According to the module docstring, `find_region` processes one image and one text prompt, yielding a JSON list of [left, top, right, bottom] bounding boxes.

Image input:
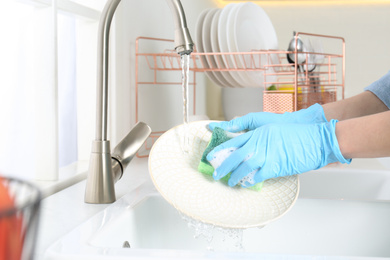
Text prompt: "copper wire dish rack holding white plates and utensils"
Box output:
[[135, 32, 345, 157]]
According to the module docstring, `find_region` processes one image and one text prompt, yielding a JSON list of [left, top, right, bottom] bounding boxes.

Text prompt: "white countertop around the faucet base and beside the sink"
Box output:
[[36, 155, 386, 260]]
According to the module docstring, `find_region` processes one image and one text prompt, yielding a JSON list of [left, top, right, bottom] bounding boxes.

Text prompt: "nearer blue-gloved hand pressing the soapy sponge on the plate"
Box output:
[[207, 119, 351, 187]]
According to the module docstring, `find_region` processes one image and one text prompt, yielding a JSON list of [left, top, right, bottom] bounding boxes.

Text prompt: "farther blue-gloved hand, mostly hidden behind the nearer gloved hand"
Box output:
[[209, 104, 327, 132]]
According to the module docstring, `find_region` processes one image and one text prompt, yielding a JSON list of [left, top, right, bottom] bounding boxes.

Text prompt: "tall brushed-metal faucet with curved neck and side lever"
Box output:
[[85, 0, 194, 204]]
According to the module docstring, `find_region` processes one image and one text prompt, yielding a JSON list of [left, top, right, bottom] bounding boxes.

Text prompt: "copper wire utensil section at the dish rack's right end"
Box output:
[[263, 32, 345, 113]]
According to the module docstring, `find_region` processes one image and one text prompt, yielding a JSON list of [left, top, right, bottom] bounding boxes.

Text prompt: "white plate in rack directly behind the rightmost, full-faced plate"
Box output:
[[218, 4, 245, 88]]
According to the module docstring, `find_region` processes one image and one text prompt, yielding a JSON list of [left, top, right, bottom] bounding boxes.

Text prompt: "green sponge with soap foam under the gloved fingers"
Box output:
[[198, 127, 263, 191]]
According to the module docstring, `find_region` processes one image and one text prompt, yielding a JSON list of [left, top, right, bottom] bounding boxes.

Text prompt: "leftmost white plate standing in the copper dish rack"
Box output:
[[195, 8, 224, 86]]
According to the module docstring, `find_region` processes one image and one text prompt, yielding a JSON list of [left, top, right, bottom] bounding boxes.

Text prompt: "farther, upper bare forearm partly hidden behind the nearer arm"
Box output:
[[322, 91, 388, 121]]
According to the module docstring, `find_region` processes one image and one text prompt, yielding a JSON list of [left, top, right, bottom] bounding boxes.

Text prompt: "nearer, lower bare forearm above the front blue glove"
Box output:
[[336, 111, 390, 159]]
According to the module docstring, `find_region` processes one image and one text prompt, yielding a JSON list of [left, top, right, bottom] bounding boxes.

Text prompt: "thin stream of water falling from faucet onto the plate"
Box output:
[[181, 54, 190, 153]]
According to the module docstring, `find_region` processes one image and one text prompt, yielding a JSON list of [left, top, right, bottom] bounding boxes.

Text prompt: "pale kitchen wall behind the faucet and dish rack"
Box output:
[[110, 0, 390, 148]]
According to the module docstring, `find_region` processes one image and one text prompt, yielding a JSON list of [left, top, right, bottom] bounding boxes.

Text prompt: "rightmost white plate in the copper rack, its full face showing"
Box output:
[[235, 2, 278, 87]]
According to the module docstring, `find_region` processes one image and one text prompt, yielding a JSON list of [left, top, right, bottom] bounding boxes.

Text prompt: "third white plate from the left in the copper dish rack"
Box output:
[[210, 9, 239, 88]]
